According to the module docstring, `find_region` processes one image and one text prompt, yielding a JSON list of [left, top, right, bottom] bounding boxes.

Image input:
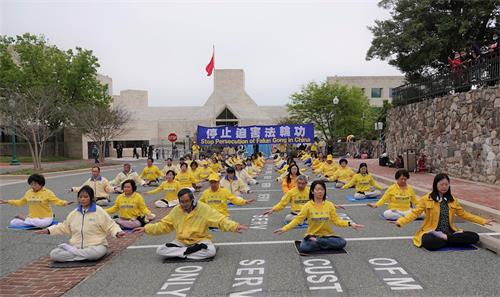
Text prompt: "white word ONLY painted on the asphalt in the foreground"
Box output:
[[156, 266, 203, 297]]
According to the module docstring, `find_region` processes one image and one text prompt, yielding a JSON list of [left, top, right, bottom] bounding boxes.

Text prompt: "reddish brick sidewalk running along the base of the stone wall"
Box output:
[[348, 159, 500, 210]]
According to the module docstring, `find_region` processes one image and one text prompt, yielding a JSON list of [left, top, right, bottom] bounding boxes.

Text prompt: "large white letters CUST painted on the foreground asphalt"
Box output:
[[302, 258, 345, 297]]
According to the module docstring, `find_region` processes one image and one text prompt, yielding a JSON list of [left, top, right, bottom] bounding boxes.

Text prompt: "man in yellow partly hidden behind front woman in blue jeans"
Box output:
[[264, 175, 310, 223]]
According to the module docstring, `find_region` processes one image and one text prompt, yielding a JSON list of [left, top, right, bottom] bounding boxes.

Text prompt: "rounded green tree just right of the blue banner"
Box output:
[[287, 82, 375, 142]]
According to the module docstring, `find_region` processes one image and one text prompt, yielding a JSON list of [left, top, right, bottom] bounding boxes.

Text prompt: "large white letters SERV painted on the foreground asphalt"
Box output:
[[229, 259, 266, 297]]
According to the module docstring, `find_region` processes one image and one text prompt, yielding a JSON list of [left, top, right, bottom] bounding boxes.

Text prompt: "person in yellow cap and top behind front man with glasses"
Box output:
[[198, 174, 255, 216]]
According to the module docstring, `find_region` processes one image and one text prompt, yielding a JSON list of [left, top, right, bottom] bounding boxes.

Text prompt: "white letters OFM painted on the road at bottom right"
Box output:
[[368, 258, 423, 291]]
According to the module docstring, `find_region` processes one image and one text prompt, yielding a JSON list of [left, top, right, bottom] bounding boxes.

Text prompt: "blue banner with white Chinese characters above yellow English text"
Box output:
[[197, 124, 314, 146]]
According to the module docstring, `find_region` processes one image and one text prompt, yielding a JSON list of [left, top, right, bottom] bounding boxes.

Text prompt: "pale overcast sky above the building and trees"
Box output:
[[0, 0, 401, 106]]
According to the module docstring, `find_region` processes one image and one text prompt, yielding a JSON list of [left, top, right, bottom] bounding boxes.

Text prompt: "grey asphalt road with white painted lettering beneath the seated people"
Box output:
[[0, 164, 500, 296]]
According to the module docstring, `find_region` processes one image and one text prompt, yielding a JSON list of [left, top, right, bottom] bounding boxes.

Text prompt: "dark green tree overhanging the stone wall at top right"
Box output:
[[366, 0, 500, 82]]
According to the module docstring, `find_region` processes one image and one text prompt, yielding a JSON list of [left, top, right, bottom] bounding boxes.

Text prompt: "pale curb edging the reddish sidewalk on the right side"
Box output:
[[372, 173, 500, 256]]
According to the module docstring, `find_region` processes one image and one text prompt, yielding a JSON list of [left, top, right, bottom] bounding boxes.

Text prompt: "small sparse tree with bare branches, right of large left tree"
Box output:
[[71, 104, 131, 162]]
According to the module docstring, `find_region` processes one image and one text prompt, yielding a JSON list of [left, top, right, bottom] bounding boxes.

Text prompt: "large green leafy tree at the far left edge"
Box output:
[[0, 33, 111, 170]]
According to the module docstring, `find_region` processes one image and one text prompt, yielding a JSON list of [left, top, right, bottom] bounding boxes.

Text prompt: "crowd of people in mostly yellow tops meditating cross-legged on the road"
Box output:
[[0, 153, 493, 262]]
